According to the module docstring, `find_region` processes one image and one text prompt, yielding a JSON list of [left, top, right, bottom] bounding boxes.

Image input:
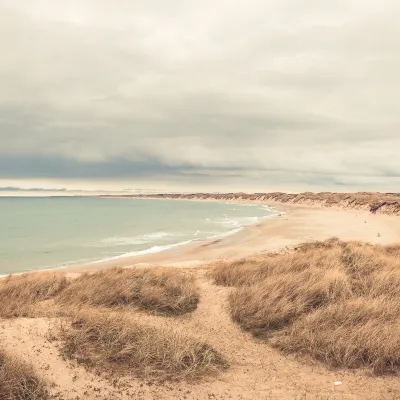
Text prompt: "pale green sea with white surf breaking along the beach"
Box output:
[[0, 197, 277, 275]]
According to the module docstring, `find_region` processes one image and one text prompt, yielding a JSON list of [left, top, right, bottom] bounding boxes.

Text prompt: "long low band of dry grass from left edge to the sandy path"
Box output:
[[0, 268, 199, 318]]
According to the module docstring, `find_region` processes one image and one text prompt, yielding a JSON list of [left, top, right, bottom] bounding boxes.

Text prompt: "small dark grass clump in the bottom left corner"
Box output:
[[0, 350, 48, 400]]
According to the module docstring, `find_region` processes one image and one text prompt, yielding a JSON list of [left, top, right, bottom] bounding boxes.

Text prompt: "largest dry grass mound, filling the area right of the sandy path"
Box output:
[[212, 239, 400, 373]]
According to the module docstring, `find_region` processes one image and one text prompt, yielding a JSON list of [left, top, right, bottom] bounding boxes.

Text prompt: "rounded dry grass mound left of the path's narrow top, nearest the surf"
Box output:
[[57, 268, 199, 315]]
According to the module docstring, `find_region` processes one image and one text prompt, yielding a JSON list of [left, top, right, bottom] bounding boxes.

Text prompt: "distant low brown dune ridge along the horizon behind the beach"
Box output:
[[105, 192, 400, 215]]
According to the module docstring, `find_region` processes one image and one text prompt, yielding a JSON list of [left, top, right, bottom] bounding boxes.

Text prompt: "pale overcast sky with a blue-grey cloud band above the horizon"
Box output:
[[0, 0, 400, 193]]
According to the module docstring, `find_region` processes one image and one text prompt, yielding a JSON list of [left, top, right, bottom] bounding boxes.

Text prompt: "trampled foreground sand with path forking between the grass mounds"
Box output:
[[0, 268, 400, 399]]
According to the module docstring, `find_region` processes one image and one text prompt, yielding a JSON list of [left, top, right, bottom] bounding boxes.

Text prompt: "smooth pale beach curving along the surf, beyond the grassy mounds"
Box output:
[[65, 200, 400, 273]]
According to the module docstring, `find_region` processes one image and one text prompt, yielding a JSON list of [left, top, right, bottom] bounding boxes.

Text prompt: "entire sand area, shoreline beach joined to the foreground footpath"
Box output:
[[0, 203, 400, 400]]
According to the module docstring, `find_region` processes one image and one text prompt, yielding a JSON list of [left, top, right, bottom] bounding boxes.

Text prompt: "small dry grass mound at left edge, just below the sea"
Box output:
[[0, 272, 68, 318]]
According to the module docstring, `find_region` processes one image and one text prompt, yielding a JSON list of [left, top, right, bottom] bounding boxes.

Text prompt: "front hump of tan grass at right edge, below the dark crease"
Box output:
[[272, 297, 400, 374]]
